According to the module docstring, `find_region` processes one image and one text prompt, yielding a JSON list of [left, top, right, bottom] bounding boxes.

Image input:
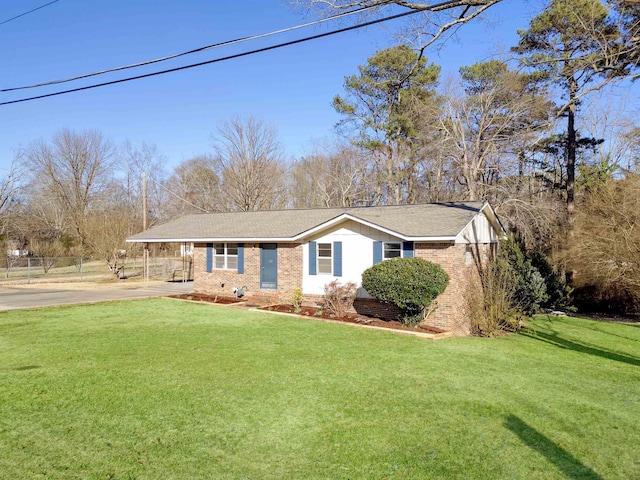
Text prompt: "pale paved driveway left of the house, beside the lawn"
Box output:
[[0, 282, 193, 311]]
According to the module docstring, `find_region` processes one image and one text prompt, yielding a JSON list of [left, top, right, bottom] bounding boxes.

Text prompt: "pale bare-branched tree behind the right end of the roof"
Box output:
[[439, 60, 550, 201]]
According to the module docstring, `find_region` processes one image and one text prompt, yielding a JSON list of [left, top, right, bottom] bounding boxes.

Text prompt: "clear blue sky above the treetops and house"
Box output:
[[0, 0, 568, 175]]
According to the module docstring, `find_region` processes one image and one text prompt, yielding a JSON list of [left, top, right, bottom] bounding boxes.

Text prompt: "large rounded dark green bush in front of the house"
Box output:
[[362, 258, 449, 325]]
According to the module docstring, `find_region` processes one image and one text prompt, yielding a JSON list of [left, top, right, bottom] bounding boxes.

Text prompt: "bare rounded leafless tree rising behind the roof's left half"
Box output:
[[213, 118, 286, 211]]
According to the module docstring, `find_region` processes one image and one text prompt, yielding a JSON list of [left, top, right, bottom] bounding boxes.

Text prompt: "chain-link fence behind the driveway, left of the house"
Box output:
[[0, 255, 193, 284]]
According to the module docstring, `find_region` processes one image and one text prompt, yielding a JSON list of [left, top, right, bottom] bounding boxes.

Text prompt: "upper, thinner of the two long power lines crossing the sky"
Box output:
[[0, 0, 389, 93]]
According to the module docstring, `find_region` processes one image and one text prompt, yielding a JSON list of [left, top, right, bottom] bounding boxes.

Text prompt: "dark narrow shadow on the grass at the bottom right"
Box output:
[[505, 415, 602, 480]]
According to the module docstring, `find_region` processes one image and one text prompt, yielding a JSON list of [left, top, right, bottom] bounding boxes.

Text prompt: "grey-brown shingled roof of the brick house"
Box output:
[[127, 202, 495, 242]]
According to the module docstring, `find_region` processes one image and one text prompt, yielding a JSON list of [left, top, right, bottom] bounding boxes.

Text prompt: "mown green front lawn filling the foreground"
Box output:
[[0, 299, 640, 479]]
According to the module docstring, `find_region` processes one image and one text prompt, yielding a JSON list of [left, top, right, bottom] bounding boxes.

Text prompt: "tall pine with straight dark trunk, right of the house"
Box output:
[[513, 0, 620, 212]]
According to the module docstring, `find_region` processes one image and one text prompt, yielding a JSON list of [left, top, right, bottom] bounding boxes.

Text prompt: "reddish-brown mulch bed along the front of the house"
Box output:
[[169, 293, 444, 333]]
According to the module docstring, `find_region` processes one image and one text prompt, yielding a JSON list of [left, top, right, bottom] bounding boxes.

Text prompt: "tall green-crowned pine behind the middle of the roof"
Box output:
[[333, 45, 440, 204]]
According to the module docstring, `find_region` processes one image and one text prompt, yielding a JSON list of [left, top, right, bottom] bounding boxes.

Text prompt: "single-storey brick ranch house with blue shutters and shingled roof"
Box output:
[[127, 202, 504, 331]]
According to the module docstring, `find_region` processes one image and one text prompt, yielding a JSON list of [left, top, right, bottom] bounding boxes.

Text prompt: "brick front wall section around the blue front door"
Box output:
[[193, 243, 302, 303]]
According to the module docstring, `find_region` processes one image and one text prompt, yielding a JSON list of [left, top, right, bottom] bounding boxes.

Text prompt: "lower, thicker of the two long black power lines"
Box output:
[[0, 6, 420, 106]]
